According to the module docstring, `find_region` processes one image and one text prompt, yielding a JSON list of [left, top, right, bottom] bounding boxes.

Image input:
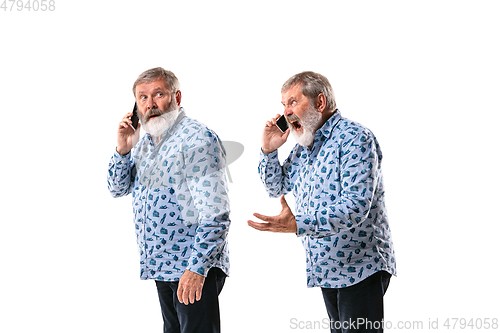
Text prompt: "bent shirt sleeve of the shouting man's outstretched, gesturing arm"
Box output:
[[295, 132, 382, 238]]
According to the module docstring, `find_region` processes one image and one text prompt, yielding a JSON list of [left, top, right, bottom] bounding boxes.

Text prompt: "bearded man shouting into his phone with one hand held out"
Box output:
[[248, 72, 396, 332]]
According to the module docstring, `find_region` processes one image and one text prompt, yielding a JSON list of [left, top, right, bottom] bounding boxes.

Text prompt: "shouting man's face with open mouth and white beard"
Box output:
[[281, 84, 321, 146]]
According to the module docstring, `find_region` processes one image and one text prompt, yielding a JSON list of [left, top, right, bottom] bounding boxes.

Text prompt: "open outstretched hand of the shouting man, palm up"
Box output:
[[248, 194, 297, 233]]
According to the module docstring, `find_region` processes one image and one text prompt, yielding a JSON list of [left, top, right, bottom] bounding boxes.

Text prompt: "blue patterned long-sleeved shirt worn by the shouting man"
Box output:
[[259, 110, 396, 288]]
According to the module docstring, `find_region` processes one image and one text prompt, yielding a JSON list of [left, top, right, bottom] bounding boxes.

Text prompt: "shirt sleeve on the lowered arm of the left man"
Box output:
[[184, 130, 230, 276]]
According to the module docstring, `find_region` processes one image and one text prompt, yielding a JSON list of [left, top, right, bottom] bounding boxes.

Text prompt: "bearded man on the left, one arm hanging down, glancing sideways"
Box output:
[[108, 68, 230, 333]]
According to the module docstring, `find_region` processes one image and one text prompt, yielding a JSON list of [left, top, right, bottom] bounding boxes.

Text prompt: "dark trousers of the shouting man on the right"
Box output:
[[321, 271, 391, 333]]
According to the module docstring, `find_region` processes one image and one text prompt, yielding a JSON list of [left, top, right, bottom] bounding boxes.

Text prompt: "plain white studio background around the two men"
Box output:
[[0, 0, 500, 333]]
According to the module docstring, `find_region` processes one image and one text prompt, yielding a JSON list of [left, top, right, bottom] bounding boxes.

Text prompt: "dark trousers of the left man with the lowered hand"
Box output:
[[155, 268, 226, 333]]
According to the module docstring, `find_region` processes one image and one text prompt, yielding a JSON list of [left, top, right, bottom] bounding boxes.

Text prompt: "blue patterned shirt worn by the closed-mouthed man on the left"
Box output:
[[108, 109, 230, 281]]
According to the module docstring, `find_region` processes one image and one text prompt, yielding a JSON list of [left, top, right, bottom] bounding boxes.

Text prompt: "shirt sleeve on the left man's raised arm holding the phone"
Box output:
[[108, 151, 135, 198]]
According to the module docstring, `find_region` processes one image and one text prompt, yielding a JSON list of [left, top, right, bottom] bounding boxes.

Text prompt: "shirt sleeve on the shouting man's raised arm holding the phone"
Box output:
[[258, 149, 293, 198]]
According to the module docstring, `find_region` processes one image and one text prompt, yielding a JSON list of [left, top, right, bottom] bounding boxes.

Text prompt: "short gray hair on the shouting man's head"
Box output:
[[281, 71, 337, 111]]
